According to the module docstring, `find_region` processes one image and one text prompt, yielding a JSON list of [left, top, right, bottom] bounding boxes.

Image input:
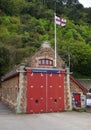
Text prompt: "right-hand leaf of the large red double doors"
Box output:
[[47, 74, 64, 112]]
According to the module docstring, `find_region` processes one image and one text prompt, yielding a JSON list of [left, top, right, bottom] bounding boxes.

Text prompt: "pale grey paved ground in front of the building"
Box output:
[[0, 102, 91, 130]]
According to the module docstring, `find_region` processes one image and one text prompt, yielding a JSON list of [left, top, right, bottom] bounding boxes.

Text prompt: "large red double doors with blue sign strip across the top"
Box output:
[[27, 69, 64, 113]]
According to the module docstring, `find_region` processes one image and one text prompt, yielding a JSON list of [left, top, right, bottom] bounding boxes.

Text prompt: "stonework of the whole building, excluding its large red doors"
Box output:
[[2, 42, 87, 113]]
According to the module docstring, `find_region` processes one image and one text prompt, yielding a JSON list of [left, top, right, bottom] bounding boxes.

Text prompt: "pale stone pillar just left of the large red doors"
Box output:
[[16, 66, 26, 113]]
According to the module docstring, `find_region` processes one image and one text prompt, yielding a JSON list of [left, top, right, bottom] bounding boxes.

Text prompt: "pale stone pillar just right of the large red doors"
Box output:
[[66, 68, 72, 110]]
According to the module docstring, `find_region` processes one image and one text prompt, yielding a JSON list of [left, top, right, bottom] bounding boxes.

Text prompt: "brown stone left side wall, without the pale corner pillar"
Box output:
[[2, 76, 19, 110]]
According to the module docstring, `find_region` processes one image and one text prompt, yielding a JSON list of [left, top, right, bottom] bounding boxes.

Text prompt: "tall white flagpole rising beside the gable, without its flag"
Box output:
[[54, 13, 57, 67]]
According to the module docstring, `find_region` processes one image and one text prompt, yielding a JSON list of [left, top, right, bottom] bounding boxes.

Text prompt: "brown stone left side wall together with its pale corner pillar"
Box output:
[[1, 70, 27, 113]]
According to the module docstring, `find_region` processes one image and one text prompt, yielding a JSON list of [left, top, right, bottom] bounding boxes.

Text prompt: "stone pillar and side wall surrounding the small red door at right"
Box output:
[[64, 72, 86, 110]]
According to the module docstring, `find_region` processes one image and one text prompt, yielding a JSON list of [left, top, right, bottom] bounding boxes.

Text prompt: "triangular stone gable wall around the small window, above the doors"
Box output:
[[26, 43, 65, 68]]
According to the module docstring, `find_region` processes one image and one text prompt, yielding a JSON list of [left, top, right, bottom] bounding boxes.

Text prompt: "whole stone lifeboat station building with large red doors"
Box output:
[[1, 42, 87, 114]]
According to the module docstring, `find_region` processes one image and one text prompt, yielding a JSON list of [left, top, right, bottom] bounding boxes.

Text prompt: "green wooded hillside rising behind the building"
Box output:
[[0, 0, 91, 78]]
